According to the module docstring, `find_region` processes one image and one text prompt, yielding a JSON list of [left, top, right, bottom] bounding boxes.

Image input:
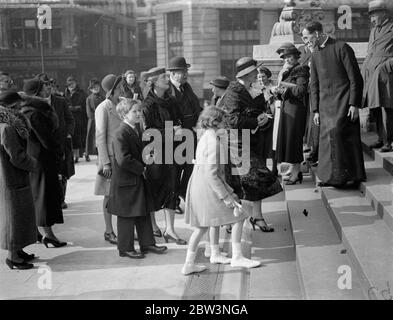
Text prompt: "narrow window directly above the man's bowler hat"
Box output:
[[167, 11, 183, 59]]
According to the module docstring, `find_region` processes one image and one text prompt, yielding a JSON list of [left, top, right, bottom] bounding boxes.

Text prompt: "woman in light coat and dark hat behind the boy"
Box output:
[[94, 74, 122, 244]]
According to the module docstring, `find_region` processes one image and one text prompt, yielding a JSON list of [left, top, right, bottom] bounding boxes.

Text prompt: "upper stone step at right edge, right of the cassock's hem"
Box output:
[[360, 157, 393, 232]]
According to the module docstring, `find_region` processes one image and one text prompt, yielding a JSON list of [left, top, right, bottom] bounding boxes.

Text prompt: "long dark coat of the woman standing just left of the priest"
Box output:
[[277, 65, 310, 163]]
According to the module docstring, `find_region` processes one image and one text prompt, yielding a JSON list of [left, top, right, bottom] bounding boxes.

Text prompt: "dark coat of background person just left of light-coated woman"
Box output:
[[86, 93, 105, 154]]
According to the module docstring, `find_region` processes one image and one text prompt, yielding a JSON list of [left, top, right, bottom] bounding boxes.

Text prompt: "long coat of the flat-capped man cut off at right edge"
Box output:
[[362, 20, 393, 108]]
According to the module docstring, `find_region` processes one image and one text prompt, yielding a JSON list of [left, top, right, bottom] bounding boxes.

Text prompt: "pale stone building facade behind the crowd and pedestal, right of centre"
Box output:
[[153, 0, 376, 99]]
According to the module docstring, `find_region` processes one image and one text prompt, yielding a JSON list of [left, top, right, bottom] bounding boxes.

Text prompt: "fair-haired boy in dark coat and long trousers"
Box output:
[[108, 99, 167, 259]]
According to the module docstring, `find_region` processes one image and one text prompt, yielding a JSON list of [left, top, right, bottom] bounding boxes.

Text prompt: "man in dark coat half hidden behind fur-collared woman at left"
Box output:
[[35, 73, 75, 209]]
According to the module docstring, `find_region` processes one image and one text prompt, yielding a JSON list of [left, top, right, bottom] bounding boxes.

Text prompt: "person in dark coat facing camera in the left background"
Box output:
[[64, 76, 87, 163]]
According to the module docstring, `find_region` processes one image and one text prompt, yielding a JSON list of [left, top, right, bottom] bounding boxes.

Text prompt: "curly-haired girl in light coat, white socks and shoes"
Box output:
[[182, 107, 260, 275]]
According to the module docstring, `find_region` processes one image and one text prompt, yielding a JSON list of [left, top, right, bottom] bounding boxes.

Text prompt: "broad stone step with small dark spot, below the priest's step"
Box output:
[[285, 176, 367, 300]]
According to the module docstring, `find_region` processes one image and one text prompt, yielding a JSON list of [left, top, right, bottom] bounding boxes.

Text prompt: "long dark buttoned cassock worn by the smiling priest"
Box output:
[[310, 38, 366, 185]]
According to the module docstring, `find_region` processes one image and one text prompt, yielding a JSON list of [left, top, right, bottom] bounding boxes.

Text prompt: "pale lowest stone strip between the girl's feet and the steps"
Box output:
[[249, 192, 303, 300]]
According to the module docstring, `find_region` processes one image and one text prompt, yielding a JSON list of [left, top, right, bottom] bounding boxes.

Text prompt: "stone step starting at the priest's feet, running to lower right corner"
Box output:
[[320, 187, 393, 300]]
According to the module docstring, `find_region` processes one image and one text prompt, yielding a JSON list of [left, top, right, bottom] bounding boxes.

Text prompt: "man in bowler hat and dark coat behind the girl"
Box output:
[[167, 57, 202, 213]]
